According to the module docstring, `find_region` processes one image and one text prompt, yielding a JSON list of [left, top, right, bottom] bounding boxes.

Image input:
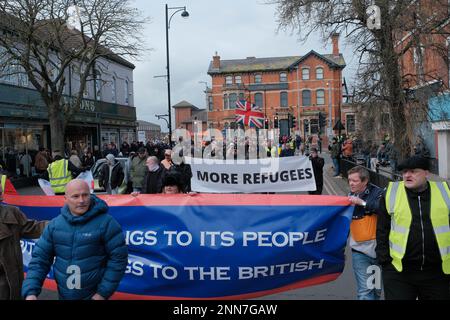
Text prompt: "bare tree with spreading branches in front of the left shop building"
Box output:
[[0, 0, 148, 151]]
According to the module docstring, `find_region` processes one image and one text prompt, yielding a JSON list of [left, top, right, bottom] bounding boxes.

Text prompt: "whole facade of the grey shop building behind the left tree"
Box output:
[[0, 54, 136, 161]]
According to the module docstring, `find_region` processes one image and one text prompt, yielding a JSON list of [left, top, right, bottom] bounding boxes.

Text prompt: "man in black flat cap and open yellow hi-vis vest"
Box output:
[[376, 156, 450, 300]]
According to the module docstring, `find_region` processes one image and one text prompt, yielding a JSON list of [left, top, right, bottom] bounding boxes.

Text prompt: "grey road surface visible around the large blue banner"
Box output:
[[14, 152, 356, 300]]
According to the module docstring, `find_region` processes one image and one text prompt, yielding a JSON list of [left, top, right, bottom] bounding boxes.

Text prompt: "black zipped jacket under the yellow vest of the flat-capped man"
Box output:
[[376, 183, 442, 271]]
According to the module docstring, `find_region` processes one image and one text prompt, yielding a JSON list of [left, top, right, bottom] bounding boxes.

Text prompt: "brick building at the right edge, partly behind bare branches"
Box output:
[[395, 1, 450, 179]]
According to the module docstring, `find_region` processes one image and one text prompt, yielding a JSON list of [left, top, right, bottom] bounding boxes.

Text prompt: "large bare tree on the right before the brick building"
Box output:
[[268, 0, 449, 156]]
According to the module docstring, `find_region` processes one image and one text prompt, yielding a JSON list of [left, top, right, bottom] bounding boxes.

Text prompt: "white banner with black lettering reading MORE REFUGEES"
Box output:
[[185, 157, 316, 193]]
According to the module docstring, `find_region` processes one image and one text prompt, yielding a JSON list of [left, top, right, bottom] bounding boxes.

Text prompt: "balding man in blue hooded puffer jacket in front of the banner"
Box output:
[[22, 180, 128, 300]]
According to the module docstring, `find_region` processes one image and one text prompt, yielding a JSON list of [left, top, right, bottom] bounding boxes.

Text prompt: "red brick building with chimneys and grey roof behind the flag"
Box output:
[[207, 34, 345, 141]]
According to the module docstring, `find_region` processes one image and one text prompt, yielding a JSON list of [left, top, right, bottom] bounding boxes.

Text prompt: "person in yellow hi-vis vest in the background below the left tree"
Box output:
[[47, 151, 82, 195]]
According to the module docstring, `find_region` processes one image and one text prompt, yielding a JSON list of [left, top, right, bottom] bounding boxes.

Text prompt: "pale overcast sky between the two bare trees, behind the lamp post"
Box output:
[[133, 0, 356, 131]]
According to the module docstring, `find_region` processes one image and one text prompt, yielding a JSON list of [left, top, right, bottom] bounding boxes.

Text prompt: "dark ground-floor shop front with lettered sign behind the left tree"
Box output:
[[0, 83, 136, 174]]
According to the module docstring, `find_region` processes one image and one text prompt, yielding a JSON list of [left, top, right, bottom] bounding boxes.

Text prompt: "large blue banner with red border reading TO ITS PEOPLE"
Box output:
[[5, 194, 353, 299]]
